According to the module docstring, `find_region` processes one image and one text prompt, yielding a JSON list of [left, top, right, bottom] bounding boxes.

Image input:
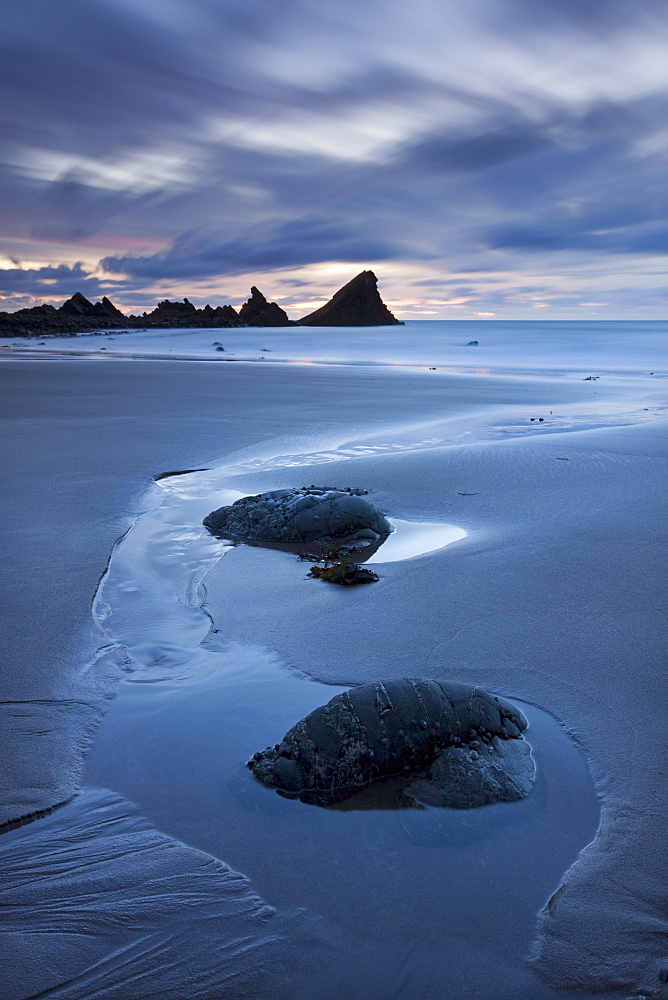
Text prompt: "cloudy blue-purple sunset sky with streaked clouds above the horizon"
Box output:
[[0, 0, 668, 319]]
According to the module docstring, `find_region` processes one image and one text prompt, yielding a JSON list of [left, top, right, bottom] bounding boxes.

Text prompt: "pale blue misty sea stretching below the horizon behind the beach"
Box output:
[[6, 320, 668, 378]]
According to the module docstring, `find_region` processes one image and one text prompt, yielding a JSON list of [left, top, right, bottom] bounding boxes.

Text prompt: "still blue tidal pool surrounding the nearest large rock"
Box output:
[[85, 644, 599, 962]]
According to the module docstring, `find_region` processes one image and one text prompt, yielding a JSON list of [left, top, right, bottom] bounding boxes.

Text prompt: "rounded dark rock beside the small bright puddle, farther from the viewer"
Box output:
[[204, 486, 392, 554]]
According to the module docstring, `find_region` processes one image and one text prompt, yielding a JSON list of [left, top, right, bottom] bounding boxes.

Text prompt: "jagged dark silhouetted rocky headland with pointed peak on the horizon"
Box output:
[[0, 271, 401, 337]]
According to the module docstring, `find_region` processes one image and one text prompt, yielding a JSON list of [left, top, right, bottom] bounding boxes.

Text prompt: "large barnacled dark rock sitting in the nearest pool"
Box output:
[[248, 677, 535, 809]]
